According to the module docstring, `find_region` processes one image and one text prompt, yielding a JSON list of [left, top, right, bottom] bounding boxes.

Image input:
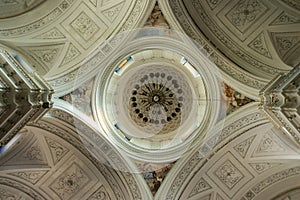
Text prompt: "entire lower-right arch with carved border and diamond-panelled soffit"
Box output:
[[155, 103, 300, 199]]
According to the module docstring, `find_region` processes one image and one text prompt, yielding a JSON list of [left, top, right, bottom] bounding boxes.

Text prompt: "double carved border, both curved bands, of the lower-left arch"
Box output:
[[30, 103, 151, 199]]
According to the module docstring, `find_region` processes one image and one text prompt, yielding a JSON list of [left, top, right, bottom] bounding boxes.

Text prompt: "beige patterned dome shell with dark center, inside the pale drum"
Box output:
[[116, 64, 193, 136]]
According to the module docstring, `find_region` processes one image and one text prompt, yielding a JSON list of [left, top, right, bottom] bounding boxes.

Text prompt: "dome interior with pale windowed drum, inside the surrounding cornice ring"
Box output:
[[103, 49, 205, 149]]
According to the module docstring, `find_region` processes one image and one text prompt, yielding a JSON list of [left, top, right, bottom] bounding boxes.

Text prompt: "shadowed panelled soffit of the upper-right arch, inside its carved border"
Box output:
[[177, 0, 299, 74]]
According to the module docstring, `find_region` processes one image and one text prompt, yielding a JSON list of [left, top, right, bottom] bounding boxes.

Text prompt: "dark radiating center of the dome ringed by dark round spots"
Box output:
[[129, 72, 184, 125]]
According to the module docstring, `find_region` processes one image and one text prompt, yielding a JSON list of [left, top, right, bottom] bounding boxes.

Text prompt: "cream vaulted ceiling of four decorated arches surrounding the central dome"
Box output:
[[0, 0, 300, 200]]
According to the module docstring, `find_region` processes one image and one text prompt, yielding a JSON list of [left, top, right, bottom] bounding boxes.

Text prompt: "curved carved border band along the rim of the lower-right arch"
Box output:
[[155, 103, 267, 200]]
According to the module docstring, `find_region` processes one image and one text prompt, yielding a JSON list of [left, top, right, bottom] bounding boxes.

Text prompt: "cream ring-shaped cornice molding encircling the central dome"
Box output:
[[92, 28, 223, 162]]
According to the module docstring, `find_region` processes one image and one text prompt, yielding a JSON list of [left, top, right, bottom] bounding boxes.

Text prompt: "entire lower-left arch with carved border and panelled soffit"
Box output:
[[0, 101, 152, 199]]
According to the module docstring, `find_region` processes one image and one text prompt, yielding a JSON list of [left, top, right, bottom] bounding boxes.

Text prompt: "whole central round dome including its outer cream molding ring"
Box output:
[[92, 29, 225, 162]]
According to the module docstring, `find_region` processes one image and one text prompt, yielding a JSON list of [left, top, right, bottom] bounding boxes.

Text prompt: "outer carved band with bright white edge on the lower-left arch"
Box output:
[[36, 103, 151, 199]]
